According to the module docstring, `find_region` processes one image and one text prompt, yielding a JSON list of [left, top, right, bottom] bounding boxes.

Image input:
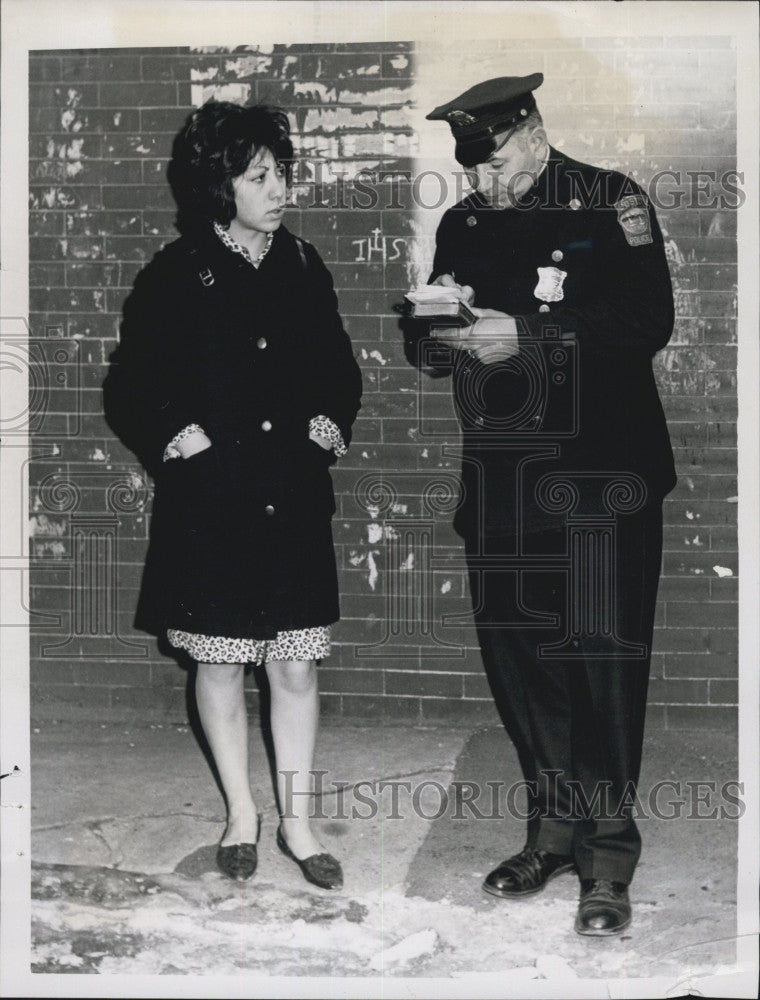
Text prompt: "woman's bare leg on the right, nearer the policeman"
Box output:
[[266, 660, 324, 858]]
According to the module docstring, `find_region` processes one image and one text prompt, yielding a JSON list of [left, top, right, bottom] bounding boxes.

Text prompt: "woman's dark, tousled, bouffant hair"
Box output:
[[168, 101, 293, 232]]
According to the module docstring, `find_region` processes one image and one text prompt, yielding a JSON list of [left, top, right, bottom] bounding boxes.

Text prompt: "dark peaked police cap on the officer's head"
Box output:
[[425, 73, 544, 167]]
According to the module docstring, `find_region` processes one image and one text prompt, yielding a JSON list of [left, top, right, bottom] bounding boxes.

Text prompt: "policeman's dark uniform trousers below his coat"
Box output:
[[467, 506, 662, 884]]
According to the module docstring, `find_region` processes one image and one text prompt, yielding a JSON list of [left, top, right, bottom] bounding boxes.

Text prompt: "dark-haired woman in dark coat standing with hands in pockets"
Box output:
[[104, 101, 361, 889]]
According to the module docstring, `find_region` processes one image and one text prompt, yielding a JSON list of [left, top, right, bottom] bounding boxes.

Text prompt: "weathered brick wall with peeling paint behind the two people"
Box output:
[[30, 38, 738, 727]]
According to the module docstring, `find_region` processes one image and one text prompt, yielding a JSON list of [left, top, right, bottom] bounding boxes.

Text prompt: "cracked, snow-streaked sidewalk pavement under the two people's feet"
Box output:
[[32, 720, 736, 984]]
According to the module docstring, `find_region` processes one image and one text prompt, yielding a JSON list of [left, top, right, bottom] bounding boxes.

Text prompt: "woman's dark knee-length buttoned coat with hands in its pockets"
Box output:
[[104, 227, 361, 639]]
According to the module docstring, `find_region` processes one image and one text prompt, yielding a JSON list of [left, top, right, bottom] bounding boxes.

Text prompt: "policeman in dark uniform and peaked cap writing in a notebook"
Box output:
[[416, 73, 676, 935]]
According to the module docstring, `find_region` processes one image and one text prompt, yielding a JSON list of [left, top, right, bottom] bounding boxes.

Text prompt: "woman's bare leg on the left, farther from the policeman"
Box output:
[[195, 663, 256, 847]]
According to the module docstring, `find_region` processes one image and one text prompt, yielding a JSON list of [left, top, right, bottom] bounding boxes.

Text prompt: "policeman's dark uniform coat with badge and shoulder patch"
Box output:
[[417, 149, 676, 537]]
